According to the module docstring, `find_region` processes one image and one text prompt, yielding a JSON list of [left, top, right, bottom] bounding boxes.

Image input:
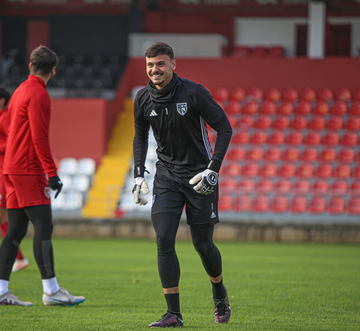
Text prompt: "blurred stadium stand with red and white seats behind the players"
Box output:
[[0, 0, 360, 242]]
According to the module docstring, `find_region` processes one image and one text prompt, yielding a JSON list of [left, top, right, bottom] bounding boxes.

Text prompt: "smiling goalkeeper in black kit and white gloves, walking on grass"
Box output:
[[133, 42, 232, 328]]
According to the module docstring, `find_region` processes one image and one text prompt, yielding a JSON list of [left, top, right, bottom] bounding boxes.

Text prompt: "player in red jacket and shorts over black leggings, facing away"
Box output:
[[0, 46, 85, 306]]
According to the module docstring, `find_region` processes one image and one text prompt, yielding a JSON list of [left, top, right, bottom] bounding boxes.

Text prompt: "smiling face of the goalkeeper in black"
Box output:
[[146, 54, 176, 90]]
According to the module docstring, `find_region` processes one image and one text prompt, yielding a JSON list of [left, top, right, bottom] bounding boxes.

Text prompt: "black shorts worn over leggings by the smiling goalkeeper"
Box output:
[[151, 175, 219, 227]]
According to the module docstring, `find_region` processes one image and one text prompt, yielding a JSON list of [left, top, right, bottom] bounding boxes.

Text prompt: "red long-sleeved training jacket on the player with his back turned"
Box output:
[[3, 75, 57, 177]]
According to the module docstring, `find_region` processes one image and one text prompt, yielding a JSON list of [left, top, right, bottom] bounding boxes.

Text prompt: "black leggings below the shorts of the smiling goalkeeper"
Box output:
[[152, 212, 222, 288]]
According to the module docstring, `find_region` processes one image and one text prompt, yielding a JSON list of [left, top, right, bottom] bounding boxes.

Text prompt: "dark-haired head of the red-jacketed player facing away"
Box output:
[[30, 45, 59, 75]]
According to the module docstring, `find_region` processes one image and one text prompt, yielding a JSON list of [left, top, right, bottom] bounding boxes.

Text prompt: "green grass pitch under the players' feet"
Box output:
[[0, 239, 360, 331]]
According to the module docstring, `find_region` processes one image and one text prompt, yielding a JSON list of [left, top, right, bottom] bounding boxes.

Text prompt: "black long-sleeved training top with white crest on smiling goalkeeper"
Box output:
[[133, 73, 232, 182]]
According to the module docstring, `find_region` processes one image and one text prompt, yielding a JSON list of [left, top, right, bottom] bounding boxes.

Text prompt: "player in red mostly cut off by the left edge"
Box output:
[[0, 85, 29, 272]]
